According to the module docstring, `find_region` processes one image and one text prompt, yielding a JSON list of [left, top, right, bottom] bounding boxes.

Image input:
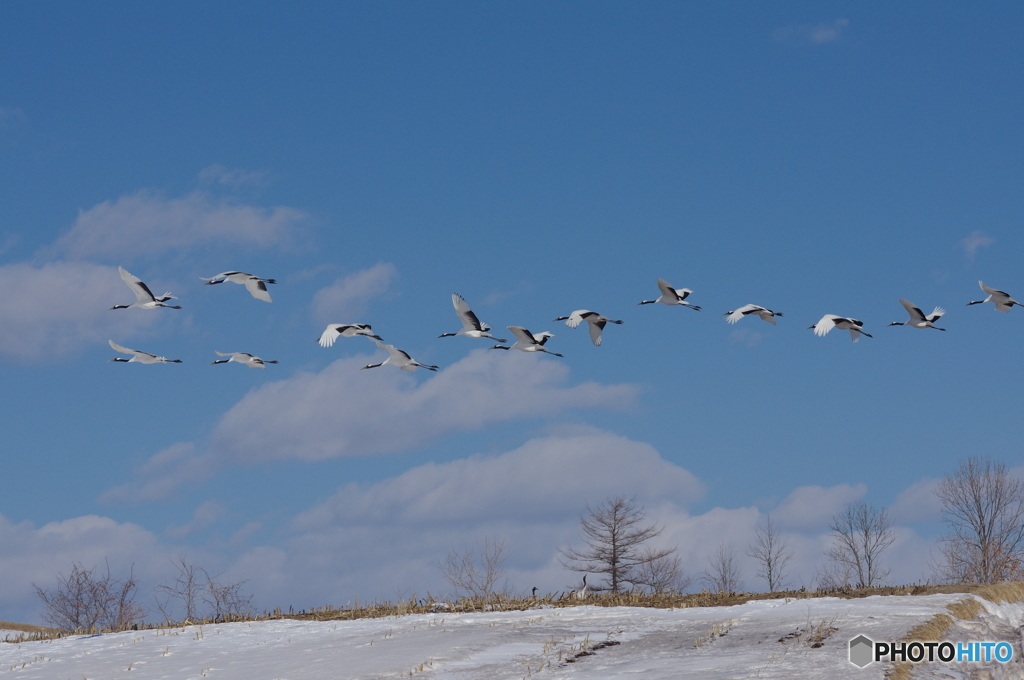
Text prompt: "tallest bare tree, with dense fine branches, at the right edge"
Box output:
[[935, 456, 1024, 583]]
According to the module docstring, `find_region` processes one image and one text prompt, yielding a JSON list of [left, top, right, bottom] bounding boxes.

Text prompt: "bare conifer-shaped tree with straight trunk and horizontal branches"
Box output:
[[558, 496, 675, 593]]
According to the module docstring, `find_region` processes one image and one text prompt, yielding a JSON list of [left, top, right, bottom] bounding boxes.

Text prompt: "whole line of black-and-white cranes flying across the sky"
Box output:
[[109, 267, 1021, 372]]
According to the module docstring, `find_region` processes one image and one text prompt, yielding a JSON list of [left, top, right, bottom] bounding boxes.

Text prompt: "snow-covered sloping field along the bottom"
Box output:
[[0, 594, 1024, 680]]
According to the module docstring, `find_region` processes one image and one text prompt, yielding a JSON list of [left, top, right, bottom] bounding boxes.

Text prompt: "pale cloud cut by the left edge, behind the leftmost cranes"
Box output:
[[0, 262, 163, 362]]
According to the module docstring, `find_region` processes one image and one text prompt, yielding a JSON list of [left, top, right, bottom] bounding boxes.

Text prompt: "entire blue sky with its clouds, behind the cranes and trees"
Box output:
[[0, 2, 1024, 620]]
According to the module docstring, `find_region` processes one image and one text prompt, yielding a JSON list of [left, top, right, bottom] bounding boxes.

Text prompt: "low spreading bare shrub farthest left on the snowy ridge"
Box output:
[[33, 562, 145, 631]]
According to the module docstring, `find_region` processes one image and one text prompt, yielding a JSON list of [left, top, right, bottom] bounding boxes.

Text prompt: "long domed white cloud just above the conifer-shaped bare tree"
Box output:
[[295, 426, 702, 530]]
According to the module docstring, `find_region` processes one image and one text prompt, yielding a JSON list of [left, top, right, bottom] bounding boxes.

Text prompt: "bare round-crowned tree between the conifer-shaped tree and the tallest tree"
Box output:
[[825, 501, 896, 588]]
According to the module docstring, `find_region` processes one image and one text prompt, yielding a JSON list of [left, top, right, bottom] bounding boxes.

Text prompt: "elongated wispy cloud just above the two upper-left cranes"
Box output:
[[44, 189, 305, 258]]
